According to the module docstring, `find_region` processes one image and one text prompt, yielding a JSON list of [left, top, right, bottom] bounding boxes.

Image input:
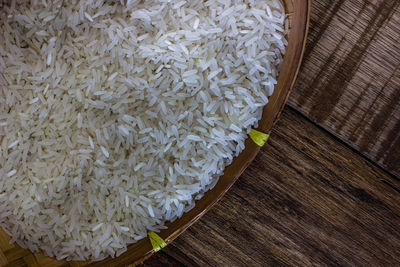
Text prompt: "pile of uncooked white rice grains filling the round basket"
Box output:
[[0, 0, 287, 260]]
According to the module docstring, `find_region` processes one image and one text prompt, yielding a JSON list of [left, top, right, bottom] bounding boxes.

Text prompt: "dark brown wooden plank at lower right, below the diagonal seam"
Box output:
[[143, 109, 400, 266]]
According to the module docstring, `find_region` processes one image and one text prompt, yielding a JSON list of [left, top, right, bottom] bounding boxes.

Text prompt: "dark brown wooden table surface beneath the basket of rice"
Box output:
[[143, 0, 400, 266]]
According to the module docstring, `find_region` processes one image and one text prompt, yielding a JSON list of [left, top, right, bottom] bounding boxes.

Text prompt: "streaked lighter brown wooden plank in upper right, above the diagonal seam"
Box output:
[[289, 0, 400, 176]]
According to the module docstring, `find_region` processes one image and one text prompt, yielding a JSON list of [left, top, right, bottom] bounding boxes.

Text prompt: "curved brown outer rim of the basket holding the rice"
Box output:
[[89, 0, 311, 266]]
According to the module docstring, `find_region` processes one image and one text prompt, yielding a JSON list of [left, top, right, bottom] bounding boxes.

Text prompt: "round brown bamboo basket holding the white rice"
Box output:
[[0, 0, 311, 267]]
